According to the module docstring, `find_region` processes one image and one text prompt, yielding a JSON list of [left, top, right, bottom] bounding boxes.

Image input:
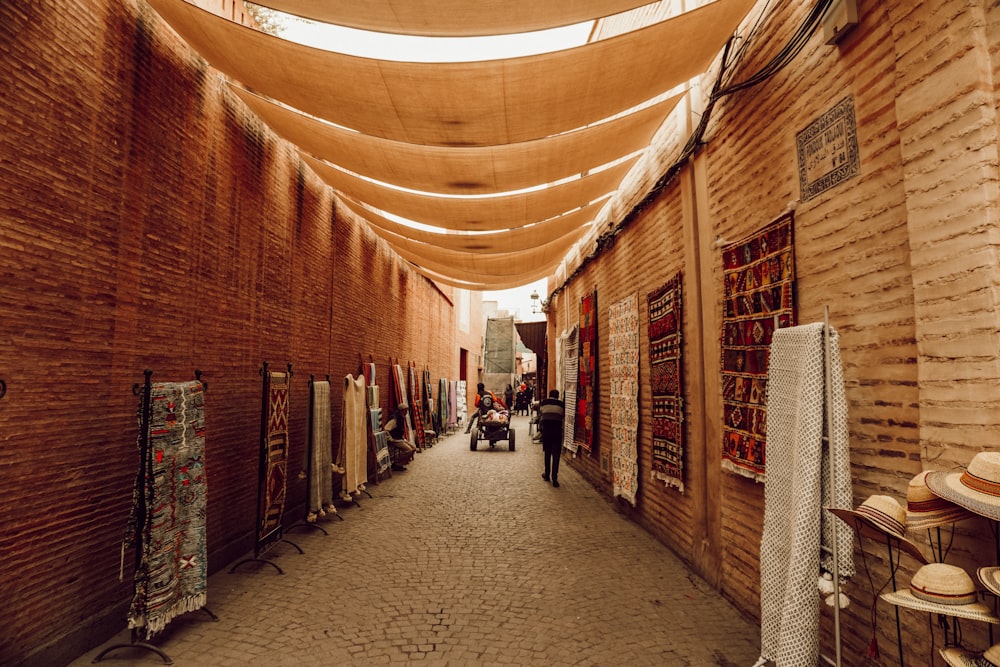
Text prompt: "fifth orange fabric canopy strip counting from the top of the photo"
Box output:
[[341, 196, 607, 254]]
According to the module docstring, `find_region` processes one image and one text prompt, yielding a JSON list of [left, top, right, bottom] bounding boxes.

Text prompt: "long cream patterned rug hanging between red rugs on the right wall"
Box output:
[[608, 294, 639, 507]]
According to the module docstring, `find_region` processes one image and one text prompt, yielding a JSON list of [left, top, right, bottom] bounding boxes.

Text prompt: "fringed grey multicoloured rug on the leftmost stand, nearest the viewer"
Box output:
[[128, 380, 208, 639]]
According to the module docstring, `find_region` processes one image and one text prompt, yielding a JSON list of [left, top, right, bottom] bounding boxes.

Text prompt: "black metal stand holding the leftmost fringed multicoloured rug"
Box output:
[[94, 368, 219, 665]]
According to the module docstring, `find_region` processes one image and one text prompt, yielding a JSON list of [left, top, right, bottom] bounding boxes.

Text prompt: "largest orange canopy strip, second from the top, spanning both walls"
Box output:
[[149, 0, 755, 146]]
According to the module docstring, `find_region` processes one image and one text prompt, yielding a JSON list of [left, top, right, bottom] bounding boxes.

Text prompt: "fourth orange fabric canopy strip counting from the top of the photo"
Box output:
[[299, 153, 636, 231]]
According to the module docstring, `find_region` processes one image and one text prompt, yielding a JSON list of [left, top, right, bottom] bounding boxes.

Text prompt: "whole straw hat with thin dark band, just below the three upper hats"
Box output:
[[881, 563, 1000, 623]]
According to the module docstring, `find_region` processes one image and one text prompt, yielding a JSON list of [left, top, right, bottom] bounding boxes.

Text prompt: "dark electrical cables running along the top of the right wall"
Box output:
[[549, 0, 834, 301]]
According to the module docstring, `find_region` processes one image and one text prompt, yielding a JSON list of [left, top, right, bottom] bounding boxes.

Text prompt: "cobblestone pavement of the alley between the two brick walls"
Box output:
[[71, 417, 759, 667]]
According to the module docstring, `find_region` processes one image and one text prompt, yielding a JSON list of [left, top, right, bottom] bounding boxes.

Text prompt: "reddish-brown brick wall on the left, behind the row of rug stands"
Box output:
[[0, 0, 481, 665]]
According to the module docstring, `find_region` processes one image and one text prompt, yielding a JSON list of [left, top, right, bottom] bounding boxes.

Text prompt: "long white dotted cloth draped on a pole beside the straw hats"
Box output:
[[760, 323, 854, 665]]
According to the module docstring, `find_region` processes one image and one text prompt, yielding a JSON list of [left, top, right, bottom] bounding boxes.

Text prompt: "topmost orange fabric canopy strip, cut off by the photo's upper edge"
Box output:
[[250, 0, 651, 37]]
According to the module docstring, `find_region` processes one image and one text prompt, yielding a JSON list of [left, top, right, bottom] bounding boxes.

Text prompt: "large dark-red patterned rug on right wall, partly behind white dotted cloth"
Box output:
[[722, 213, 795, 482]]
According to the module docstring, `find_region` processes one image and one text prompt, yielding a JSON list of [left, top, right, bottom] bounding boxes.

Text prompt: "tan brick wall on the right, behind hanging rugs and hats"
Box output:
[[549, 0, 1000, 665]]
